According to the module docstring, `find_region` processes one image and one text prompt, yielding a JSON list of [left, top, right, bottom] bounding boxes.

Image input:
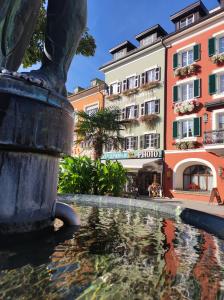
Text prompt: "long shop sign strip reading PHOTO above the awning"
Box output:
[[101, 150, 163, 160]]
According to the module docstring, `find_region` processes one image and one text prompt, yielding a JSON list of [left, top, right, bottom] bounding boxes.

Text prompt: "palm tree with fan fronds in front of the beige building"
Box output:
[[75, 108, 125, 160]]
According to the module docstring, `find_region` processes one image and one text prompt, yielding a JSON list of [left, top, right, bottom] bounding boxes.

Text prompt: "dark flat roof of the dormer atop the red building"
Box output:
[[170, 0, 209, 23]]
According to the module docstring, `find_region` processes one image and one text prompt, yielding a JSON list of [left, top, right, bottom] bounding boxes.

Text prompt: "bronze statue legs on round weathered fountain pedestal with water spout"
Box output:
[[0, 0, 87, 234]]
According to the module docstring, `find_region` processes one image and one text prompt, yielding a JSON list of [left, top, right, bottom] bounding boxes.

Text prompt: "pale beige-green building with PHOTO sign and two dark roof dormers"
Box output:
[[100, 25, 167, 194]]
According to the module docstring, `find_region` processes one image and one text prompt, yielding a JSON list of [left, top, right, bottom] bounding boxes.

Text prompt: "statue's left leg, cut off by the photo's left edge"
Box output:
[[0, 0, 41, 71]]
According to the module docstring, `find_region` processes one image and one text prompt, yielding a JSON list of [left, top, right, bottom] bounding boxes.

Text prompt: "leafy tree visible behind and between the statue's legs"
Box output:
[[22, 0, 96, 68]]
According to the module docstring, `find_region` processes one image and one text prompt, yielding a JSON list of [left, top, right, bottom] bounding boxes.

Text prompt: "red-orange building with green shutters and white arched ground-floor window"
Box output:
[[164, 0, 224, 201]]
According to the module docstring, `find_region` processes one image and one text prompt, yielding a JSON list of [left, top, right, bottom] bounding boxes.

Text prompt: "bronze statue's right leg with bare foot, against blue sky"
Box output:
[[27, 0, 87, 96]]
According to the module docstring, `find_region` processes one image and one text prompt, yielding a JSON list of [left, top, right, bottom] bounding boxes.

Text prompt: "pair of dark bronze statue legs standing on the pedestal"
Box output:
[[0, 0, 87, 96]]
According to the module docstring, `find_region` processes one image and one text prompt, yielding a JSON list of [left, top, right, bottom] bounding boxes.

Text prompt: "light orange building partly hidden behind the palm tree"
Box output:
[[68, 78, 106, 157]]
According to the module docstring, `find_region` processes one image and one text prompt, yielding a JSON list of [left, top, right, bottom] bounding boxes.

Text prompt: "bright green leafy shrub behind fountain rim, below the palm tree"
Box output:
[[58, 157, 127, 196]]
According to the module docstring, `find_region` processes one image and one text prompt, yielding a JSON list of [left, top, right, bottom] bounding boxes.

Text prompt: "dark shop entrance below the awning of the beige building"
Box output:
[[138, 172, 161, 195]]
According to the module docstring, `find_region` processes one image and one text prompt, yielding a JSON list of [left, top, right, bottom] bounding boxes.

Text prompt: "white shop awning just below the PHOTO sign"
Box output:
[[105, 158, 163, 171]]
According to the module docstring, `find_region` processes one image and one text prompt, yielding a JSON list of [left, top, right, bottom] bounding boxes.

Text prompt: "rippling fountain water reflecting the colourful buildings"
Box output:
[[0, 206, 224, 300]]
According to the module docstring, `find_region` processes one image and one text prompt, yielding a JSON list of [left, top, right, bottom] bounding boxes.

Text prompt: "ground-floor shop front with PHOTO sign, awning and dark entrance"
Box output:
[[102, 150, 163, 195]]
